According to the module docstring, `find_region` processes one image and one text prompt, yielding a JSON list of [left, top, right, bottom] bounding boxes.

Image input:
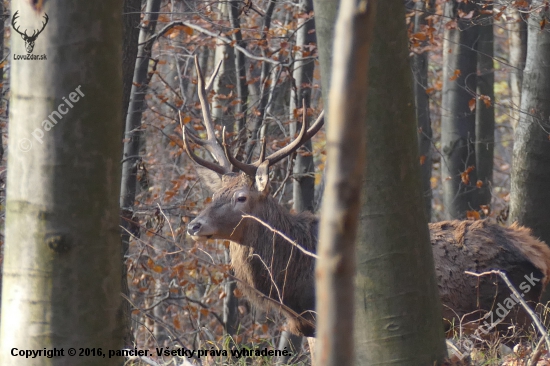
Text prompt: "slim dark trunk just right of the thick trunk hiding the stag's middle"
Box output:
[[411, 0, 434, 220]]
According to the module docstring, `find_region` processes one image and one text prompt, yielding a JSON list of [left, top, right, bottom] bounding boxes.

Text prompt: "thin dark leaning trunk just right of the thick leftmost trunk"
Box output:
[[120, 0, 161, 343]]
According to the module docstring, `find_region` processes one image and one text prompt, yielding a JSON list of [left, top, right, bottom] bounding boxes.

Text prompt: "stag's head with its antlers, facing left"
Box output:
[[182, 57, 324, 243]]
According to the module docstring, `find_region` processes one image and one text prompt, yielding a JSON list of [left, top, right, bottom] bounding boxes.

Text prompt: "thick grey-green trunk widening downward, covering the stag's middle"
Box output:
[[354, 0, 446, 366]]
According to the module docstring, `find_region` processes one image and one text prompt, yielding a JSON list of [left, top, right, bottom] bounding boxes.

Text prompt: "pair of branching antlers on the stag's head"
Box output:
[[182, 56, 325, 177]]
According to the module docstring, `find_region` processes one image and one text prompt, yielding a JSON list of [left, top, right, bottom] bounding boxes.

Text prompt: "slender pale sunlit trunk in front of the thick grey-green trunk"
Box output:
[[316, 0, 378, 366]]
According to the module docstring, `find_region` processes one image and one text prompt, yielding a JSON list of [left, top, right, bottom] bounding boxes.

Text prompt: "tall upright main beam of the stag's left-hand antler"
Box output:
[[195, 55, 231, 172]]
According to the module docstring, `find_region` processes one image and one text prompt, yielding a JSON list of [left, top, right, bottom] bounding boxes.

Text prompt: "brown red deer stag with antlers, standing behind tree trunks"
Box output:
[[183, 58, 550, 337]]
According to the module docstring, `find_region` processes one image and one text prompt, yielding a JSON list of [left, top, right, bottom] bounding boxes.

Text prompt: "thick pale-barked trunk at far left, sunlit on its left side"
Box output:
[[0, 0, 122, 366]]
